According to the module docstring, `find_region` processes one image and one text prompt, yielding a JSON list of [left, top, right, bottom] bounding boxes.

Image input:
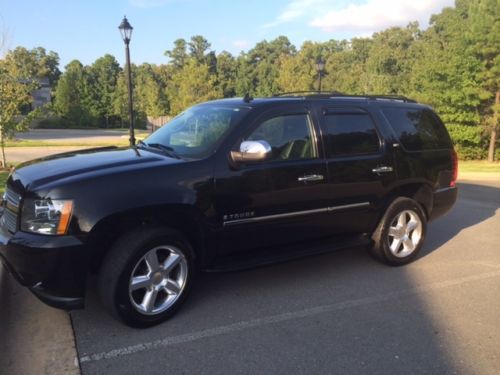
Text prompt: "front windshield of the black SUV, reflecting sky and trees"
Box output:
[[144, 104, 249, 158]]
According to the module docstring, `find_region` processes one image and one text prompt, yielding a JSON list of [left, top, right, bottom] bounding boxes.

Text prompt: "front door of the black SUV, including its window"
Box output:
[[215, 105, 329, 255]]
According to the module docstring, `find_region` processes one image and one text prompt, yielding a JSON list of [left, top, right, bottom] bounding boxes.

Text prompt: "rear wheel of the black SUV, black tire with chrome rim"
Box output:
[[370, 197, 427, 266]]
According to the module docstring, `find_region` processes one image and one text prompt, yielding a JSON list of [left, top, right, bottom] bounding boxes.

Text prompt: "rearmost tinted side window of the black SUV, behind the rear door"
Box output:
[[382, 108, 451, 151]]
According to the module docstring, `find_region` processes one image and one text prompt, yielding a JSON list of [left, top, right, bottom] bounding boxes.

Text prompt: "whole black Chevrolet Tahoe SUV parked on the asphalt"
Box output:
[[0, 93, 457, 326]]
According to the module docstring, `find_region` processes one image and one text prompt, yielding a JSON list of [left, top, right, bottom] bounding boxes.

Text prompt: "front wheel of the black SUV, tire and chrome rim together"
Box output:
[[99, 228, 195, 327]]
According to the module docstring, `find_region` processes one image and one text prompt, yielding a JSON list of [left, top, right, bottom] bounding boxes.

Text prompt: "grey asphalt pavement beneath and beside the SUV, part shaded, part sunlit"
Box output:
[[62, 180, 500, 374]]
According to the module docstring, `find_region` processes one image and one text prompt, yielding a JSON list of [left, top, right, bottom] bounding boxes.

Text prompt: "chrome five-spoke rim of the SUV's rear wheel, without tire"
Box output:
[[388, 210, 422, 258]]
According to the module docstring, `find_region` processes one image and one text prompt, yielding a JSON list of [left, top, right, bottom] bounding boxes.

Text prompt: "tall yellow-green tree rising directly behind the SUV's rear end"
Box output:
[[408, 8, 484, 158]]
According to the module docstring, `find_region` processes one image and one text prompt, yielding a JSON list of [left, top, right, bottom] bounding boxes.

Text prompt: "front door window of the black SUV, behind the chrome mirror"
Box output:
[[247, 114, 316, 160]]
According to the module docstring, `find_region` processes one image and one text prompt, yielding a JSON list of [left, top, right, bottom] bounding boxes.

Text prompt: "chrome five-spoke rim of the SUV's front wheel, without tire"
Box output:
[[129, 245, 188, 315]]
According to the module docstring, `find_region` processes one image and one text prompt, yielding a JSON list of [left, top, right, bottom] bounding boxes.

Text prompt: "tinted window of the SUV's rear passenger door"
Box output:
[[325, 113, 380, 156]]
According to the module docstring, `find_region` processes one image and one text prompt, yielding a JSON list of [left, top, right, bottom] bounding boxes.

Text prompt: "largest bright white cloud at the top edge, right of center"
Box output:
[[310, 0, 454, 33]]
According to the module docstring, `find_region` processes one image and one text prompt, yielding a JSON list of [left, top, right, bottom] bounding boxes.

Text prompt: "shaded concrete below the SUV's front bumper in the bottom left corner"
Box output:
[[0, 263, 80, 375]]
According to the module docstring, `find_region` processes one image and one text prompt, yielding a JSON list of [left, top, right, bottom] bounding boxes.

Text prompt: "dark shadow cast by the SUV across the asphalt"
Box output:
[[72, 183, 500, 374]]
